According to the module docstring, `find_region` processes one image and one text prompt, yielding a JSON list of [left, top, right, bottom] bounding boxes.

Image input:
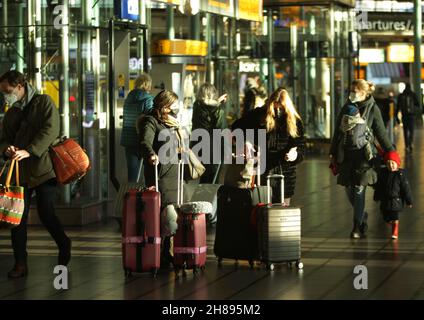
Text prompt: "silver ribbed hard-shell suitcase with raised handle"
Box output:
[[256, 175, 303, 271]]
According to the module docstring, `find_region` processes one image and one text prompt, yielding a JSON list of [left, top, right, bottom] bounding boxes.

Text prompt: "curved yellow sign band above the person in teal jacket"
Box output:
[[152, 39, 208, 57]]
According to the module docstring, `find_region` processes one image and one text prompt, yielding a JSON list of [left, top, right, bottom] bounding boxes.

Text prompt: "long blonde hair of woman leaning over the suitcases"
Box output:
[[264, 88, 300, 138]]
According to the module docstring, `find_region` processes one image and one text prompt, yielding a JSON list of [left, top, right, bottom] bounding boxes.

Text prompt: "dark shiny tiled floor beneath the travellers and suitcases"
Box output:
[[0, 125, 424, 300]]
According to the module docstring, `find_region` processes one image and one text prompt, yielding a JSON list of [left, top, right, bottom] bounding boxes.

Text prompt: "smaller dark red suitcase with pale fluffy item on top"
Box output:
[[173, 161, 212, 275]]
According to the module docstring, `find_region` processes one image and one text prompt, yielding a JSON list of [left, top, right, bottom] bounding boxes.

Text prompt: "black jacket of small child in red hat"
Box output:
[[374, 168, 412, 211]]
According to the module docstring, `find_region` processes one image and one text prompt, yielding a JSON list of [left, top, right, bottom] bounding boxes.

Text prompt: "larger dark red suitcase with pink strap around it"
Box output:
[[122, 165, 161, 276]]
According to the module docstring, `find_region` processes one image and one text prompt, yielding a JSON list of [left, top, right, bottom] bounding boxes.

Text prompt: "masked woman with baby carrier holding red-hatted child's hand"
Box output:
[[330, 79, 394, 238]]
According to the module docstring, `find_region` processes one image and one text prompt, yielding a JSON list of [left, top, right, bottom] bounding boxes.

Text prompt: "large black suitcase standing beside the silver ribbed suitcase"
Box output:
[[214, 155, 267, 267]]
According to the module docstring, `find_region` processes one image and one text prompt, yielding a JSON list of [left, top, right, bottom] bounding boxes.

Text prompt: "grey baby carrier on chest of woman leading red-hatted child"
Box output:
[[343, 107, 373, 150]]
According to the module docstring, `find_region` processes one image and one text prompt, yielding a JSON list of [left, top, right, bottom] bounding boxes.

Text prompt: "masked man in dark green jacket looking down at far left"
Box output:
[[0, 70, 71, 278]]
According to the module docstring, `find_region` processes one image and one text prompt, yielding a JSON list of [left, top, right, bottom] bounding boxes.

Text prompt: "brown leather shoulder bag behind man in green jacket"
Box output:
[[49, 138, 90, 184]]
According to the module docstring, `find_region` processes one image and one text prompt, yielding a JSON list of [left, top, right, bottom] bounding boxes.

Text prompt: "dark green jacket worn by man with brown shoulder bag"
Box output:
[[0, 94, 60, 188]]
